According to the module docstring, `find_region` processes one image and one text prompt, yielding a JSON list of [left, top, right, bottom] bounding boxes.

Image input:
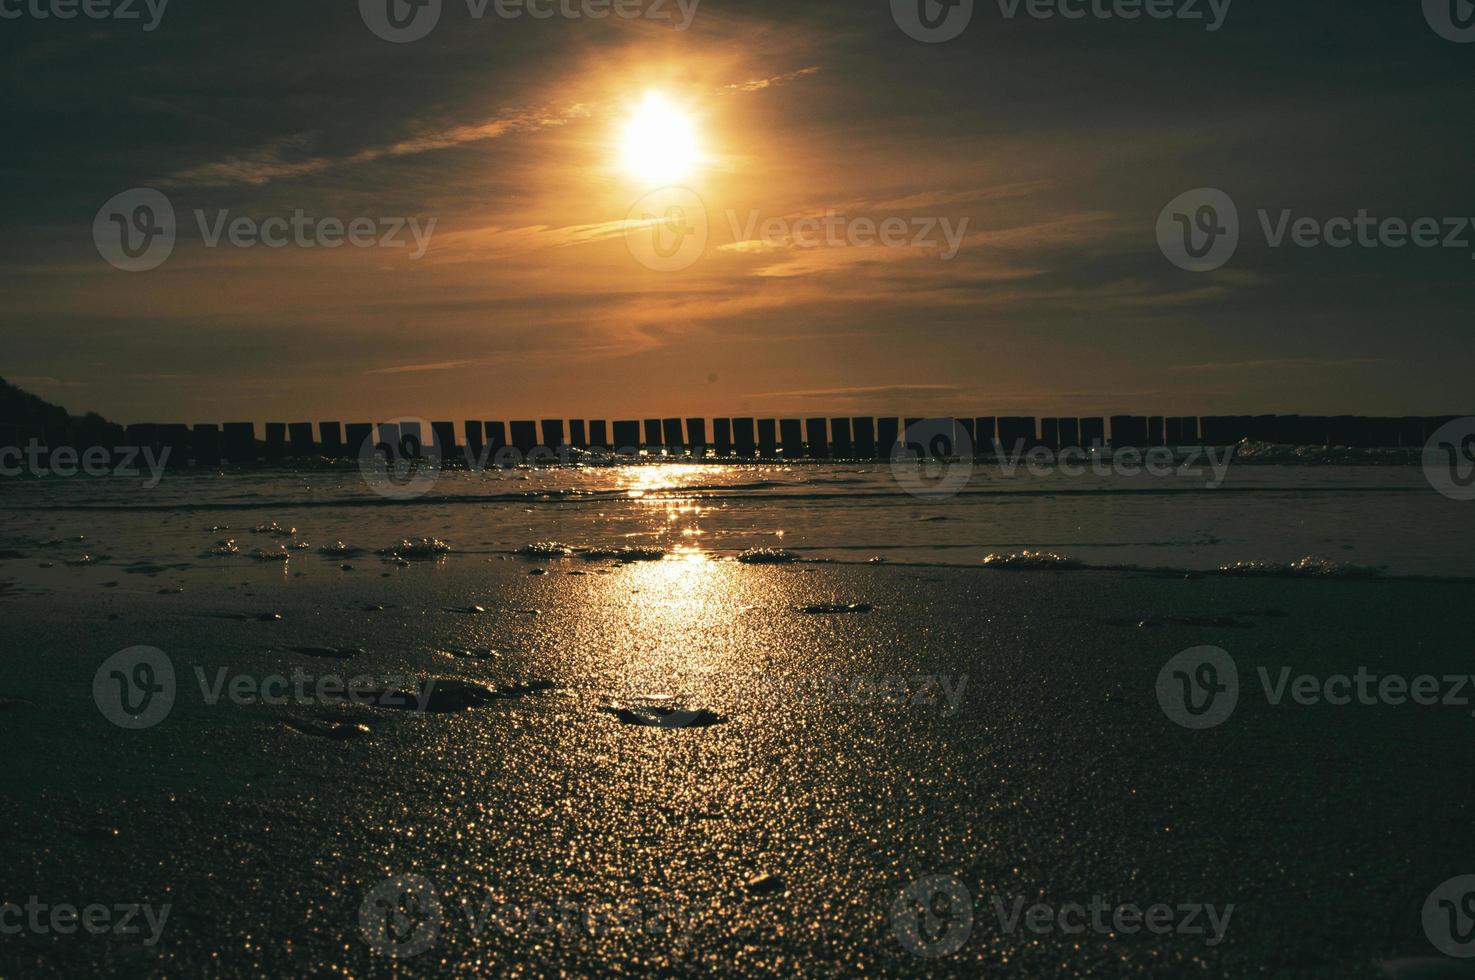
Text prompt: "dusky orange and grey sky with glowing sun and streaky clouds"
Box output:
[[0, 0, 1475, 422]]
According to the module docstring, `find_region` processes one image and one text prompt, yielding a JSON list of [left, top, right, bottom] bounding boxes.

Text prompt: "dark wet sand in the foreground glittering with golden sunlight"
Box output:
[[0, 552, 1475, 977]]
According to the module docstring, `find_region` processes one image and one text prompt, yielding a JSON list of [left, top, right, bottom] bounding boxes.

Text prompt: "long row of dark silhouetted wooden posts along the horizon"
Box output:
[[0, 415, 1460, 465]]
